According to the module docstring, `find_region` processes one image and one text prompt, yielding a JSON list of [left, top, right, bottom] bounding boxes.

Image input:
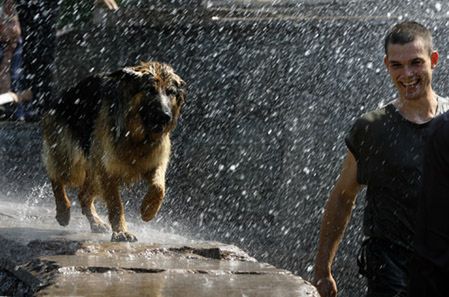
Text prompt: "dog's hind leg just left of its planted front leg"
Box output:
[[78, 179, 110, 233]]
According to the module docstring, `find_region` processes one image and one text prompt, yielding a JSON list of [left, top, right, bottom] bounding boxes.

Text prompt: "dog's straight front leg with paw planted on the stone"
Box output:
[[101, 173, 137, 242]]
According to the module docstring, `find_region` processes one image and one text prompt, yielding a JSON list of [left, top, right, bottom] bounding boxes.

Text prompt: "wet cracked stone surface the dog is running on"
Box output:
[[0, 199, 318, 297]]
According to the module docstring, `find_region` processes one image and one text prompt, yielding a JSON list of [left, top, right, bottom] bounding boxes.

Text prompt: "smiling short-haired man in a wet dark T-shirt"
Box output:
[[314, 21, 449, 297]]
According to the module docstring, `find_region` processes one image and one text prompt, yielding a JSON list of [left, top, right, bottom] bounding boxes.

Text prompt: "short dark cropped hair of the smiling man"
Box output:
[[384, 21, 433, 55]]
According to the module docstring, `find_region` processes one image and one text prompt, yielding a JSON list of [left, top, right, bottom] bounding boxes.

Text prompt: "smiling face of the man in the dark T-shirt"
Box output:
[[384, 38, 438, 100]]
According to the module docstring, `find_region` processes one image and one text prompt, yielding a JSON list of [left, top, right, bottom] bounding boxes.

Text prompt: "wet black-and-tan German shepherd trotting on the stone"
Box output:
[[42, 62, 186, 241]]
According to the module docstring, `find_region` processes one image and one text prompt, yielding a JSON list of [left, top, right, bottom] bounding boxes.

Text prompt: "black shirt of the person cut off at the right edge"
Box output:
[[416, 112, 449, 269]]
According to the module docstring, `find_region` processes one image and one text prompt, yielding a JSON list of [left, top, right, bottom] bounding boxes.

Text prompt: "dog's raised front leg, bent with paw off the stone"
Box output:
[[140, 164, 167, 222]]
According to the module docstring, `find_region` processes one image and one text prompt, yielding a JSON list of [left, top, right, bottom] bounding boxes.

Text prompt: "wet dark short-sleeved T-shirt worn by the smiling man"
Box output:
[[345, 98, 449, 250]]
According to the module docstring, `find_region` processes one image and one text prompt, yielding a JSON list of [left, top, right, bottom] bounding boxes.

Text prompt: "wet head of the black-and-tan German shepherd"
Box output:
[[110, 62, 186, 141]]
